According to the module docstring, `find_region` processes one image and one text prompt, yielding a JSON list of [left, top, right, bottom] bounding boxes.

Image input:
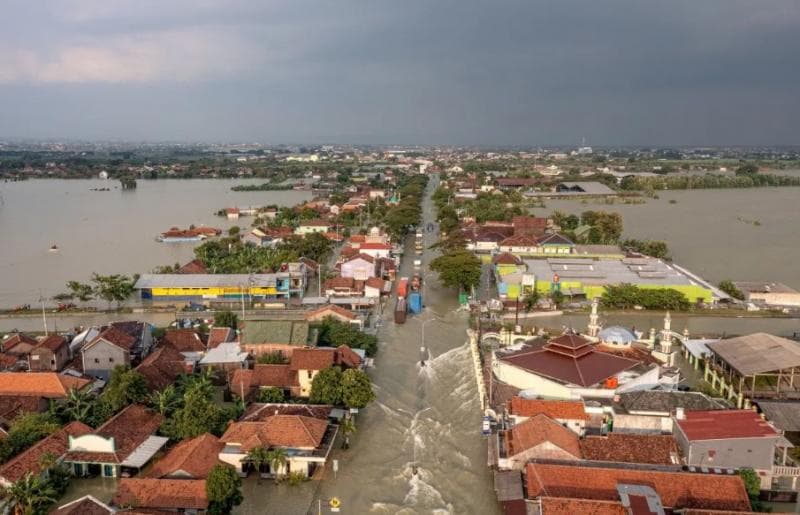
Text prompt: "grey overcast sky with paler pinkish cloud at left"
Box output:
[[0, 0, 800, 146]]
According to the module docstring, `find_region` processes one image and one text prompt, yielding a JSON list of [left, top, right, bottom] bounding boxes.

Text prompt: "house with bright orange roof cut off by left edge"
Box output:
[[0, 372, 91, 423]]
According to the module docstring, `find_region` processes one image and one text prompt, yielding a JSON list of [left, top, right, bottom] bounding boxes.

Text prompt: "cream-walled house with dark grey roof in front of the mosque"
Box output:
[[611, 390, 727, 434]]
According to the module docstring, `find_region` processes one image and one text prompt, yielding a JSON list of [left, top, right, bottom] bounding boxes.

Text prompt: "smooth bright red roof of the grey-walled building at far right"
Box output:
[[675, 410, 779, 442]]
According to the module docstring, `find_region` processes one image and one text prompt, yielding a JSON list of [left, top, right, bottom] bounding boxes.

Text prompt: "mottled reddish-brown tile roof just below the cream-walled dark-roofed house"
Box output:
[[581, 433, 678, 465]]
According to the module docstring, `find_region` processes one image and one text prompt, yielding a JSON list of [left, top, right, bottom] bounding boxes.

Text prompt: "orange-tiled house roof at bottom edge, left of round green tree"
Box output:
[[111, 478, 208, 513]]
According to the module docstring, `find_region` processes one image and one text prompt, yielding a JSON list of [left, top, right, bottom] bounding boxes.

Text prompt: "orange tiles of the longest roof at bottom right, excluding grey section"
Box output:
[[526, 463, 750, 511]]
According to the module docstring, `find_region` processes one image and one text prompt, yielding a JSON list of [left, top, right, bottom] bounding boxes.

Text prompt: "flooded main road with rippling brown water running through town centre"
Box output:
[[315, 176, 499, 515]]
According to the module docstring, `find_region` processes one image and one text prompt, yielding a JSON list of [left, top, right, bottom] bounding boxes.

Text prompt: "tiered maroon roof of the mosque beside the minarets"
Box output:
[[500, 335, 640, 387]]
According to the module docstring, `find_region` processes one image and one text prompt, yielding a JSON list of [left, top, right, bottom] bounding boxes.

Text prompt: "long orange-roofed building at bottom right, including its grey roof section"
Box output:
[[525, 463, 750, 513]]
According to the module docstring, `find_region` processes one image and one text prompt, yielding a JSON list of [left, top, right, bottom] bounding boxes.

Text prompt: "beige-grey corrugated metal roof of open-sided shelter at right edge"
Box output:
[[708, 333, 800, 376]]
